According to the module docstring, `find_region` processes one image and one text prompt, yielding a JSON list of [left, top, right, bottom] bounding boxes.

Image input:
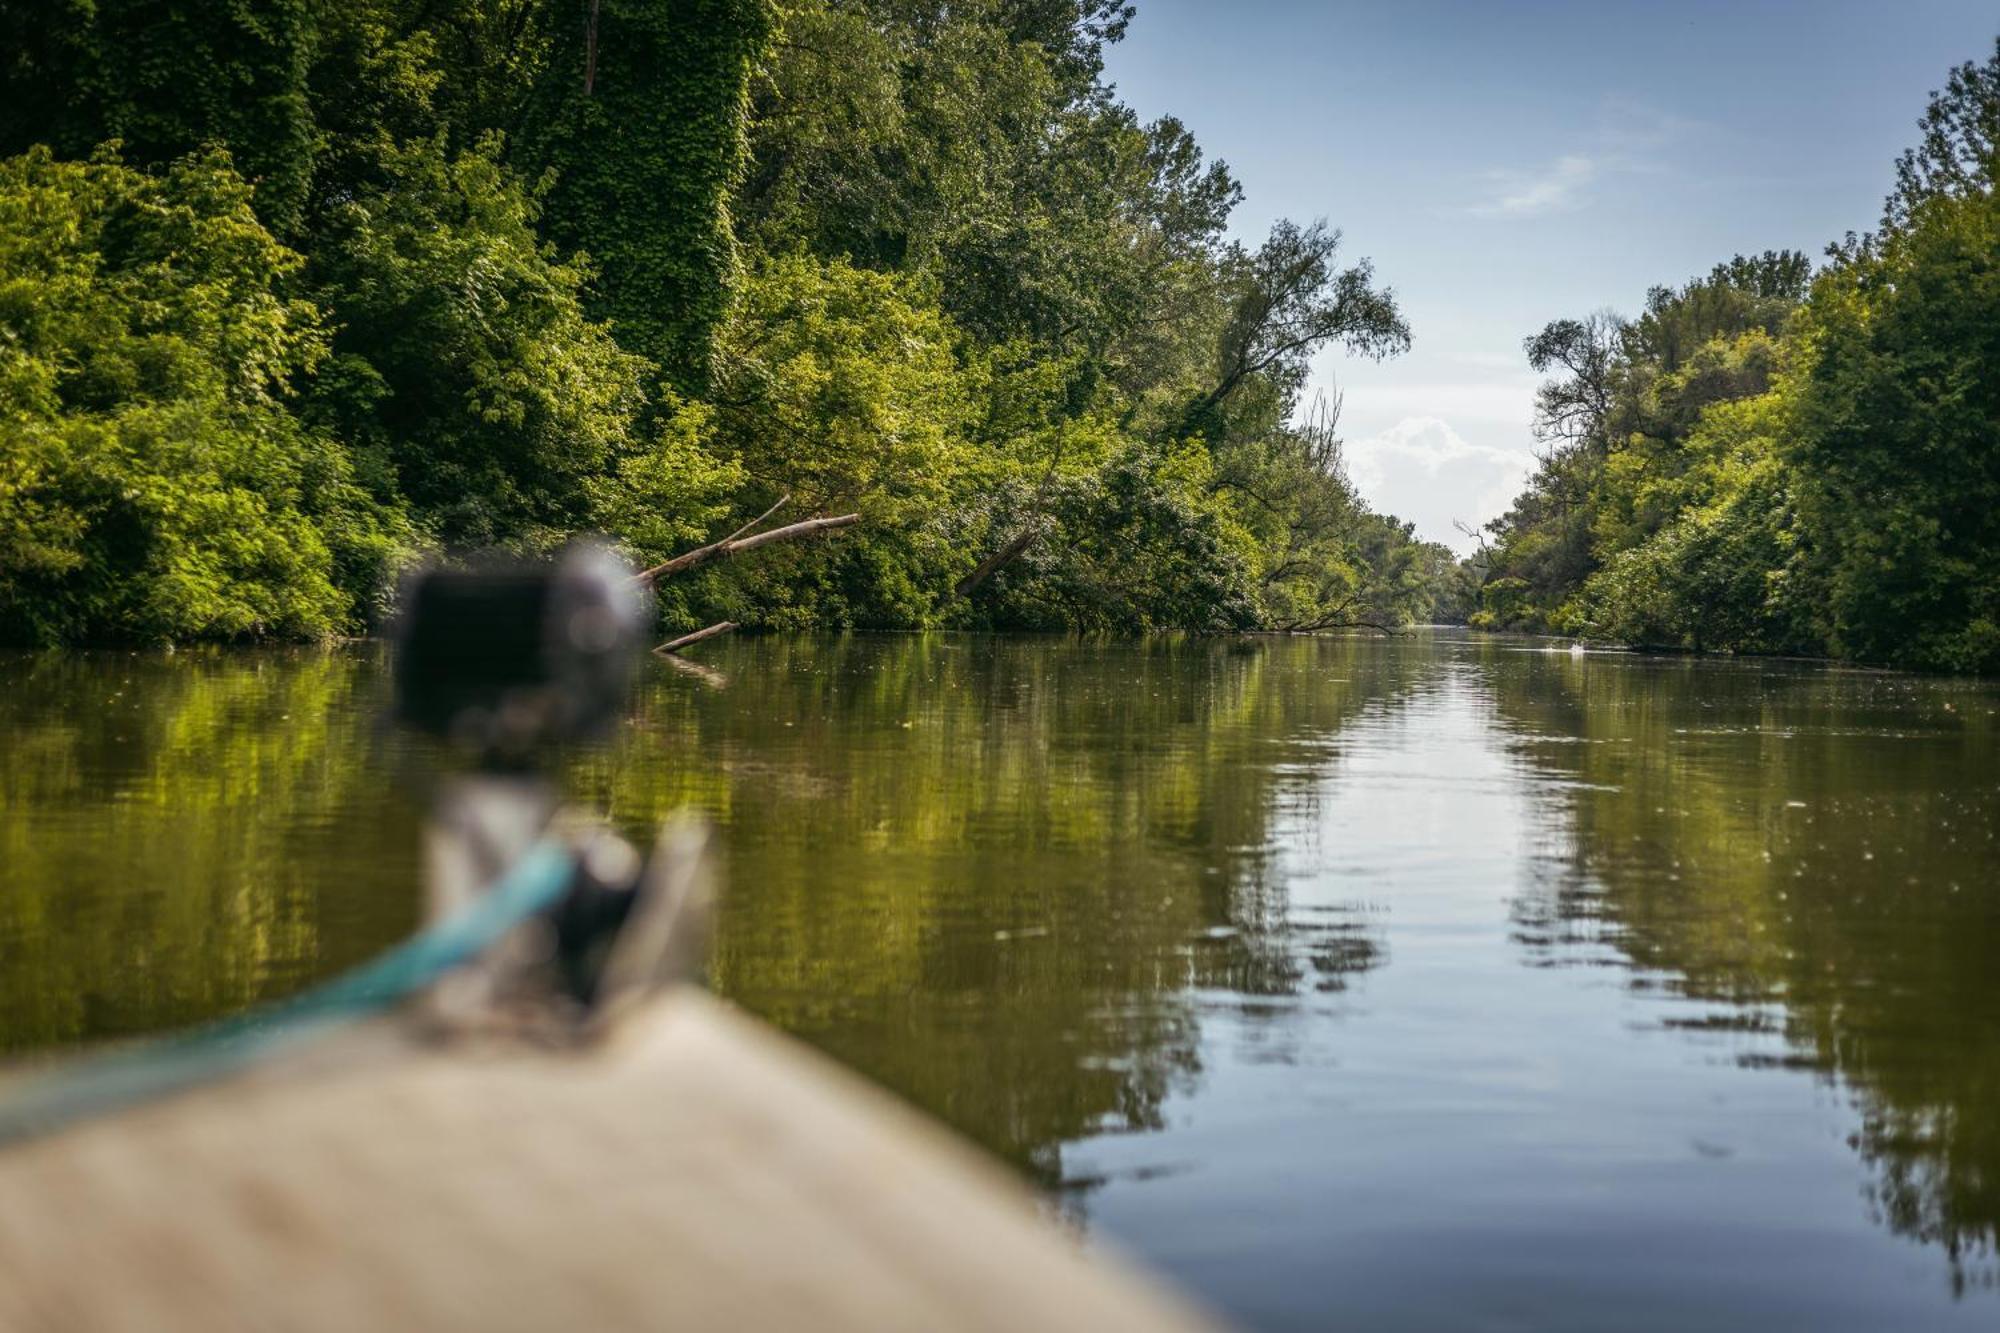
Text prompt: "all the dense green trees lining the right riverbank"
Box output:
[[1474, 44, 2000, 671]]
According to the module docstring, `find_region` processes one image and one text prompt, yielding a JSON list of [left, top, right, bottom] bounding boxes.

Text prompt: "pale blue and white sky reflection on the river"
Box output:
[[1068, 652, 2000, 1329]]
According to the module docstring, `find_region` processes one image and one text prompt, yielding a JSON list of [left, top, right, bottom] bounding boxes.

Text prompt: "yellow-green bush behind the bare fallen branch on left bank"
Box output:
[[660, 256, 992, 626]]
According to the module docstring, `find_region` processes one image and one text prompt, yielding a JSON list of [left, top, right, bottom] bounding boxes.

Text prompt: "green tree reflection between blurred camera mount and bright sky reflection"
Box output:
[[584, 636, 1412, 1183]]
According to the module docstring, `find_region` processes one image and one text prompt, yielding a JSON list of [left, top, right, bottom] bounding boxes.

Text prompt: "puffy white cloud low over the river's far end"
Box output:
[[1346, 416, 1534, 552]]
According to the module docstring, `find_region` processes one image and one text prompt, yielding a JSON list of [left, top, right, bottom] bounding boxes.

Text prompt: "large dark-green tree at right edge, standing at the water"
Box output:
[[1790, 179, 2000, 671]]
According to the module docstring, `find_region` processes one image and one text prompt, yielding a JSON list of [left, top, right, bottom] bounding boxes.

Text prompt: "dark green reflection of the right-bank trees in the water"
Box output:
[[1484, 650, 2000, 1289]]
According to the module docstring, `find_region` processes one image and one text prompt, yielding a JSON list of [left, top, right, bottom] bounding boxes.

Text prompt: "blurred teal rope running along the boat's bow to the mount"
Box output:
[[0, 841, 576, 1145]]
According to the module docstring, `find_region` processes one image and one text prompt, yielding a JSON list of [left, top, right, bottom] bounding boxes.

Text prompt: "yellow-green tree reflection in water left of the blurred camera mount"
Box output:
[[0, 648, 416, 1053]]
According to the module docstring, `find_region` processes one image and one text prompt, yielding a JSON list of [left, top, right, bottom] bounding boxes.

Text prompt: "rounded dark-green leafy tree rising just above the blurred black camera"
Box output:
[[310, 136, 650, 546]]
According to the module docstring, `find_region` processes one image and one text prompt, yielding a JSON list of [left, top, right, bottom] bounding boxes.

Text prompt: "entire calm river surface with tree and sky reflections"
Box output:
[[0, 632, 2000, 1331]]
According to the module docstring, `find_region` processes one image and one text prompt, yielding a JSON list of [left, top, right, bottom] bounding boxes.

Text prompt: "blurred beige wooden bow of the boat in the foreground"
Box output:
[[0, 987, 1208, 1333]]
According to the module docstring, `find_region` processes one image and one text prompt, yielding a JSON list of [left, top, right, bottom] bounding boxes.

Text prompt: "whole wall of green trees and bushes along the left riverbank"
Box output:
[[0, 0, 1452, 642]]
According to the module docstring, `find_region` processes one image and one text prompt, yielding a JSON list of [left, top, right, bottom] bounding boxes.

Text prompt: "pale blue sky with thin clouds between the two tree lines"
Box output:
[[1106, 0, 2000, 550]]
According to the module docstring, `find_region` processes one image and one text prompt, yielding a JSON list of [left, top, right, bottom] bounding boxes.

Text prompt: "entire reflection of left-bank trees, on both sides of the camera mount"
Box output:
[[0, 636, 1408, 1183]]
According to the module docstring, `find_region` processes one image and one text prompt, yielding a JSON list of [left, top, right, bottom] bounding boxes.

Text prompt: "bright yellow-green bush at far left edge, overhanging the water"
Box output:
[[0, 148, 402, 642]]
